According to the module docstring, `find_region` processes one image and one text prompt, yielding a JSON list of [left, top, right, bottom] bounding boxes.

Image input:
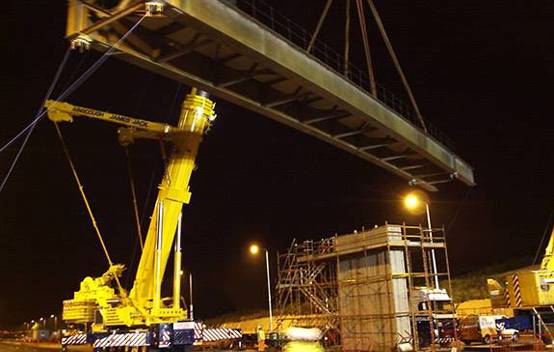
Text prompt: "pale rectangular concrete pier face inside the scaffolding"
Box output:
[[337, 238, 411, 351]]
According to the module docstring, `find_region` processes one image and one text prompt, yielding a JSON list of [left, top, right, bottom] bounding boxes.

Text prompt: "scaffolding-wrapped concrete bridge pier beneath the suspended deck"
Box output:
[[277, 224, 456, 352]]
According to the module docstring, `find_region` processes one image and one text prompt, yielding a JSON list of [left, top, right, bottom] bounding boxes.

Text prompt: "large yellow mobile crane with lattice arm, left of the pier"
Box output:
[[45, 88, 216, 331]]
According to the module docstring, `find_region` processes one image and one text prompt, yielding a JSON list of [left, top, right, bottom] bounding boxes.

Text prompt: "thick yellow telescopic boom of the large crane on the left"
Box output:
[[130, 88, 215, 319]]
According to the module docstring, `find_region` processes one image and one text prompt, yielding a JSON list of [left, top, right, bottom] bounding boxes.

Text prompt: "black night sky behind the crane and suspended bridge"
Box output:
[[0, 0, 554, 326]]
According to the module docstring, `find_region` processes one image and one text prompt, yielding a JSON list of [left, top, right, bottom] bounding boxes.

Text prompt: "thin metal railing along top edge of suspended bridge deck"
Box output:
[[223, 0, 454, 149]]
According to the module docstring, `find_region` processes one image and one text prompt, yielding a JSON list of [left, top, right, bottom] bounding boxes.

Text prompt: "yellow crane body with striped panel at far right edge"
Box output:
[[487, 227, 554, 308]]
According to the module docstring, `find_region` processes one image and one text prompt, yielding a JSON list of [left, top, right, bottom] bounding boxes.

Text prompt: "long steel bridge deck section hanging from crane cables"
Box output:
[[64, 0, 475, 191]]
